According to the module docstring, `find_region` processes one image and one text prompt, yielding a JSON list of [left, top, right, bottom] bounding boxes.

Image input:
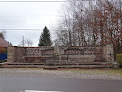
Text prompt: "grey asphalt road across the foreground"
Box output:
[[0, 76, 122, 92]]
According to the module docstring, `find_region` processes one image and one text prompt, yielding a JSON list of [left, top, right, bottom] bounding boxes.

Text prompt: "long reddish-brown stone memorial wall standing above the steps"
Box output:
[[8, 45, 113, 63]]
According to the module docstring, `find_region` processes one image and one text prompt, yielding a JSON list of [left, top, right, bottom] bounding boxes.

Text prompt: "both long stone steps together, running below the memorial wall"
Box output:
[[0, 62, 113, 68]]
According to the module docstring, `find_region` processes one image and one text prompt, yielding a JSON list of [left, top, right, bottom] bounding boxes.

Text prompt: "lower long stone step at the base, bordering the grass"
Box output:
[[0, 64, 113, 69]]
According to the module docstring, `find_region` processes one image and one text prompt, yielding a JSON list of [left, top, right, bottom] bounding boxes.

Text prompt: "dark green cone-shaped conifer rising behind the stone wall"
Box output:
[[38, 26, 52, 46]]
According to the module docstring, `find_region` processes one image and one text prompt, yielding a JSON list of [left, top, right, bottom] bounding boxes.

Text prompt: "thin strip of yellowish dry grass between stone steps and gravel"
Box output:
[[1, 68, 122, 76]]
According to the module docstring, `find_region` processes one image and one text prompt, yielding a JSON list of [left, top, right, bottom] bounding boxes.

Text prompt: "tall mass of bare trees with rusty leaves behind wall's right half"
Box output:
[[57, 0, 122, 53]]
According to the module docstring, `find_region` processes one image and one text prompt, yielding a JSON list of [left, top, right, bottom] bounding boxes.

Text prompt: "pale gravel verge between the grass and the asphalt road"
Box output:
[[0, 68, 122, 80]]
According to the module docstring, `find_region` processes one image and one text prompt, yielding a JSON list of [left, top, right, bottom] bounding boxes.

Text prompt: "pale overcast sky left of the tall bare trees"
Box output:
[[0, 0, 64, 46]]
